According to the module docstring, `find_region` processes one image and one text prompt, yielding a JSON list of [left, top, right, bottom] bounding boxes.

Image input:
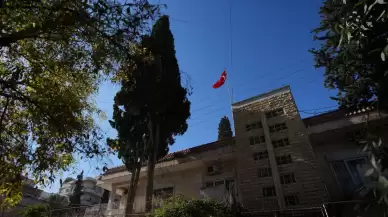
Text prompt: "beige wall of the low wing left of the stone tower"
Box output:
[[104, 141, 236, 213]]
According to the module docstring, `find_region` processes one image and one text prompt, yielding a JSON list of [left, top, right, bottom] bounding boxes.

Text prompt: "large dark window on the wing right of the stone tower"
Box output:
[[331, 157, 366, 196]]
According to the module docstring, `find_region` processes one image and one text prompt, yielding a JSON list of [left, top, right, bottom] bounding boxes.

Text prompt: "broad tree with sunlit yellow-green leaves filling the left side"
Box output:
[[0, 0, 159, 210]]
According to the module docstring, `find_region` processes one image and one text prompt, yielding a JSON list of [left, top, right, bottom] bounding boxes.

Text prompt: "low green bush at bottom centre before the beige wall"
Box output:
[[149, 197, 244, 217]]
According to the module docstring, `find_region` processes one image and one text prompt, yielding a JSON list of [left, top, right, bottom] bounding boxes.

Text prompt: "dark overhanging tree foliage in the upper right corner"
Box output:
[[311, 0, 388, 109]]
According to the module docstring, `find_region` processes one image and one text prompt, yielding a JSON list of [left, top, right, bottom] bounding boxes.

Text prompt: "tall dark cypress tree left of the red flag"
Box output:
[[116, 16, 190, 211]]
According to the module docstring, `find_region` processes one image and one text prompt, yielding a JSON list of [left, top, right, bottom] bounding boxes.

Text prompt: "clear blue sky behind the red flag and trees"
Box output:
[[45, 0, 336, 192]]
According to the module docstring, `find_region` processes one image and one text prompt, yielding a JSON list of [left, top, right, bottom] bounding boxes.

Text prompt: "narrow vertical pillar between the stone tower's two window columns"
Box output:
[[261, 112, 286, 210]]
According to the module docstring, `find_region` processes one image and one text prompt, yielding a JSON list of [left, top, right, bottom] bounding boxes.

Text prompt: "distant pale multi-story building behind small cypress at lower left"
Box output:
[[58, 177, 104, 205]]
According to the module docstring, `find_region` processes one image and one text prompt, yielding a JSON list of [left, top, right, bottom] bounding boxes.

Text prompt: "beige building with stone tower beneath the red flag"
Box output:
[[98, 86, 388, 214]]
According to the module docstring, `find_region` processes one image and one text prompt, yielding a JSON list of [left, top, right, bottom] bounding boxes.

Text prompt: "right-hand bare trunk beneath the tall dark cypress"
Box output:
[[146, 124, 159, 212]]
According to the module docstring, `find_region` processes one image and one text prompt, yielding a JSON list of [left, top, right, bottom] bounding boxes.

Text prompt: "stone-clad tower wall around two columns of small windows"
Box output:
[[233, 87, 327, 210]]
